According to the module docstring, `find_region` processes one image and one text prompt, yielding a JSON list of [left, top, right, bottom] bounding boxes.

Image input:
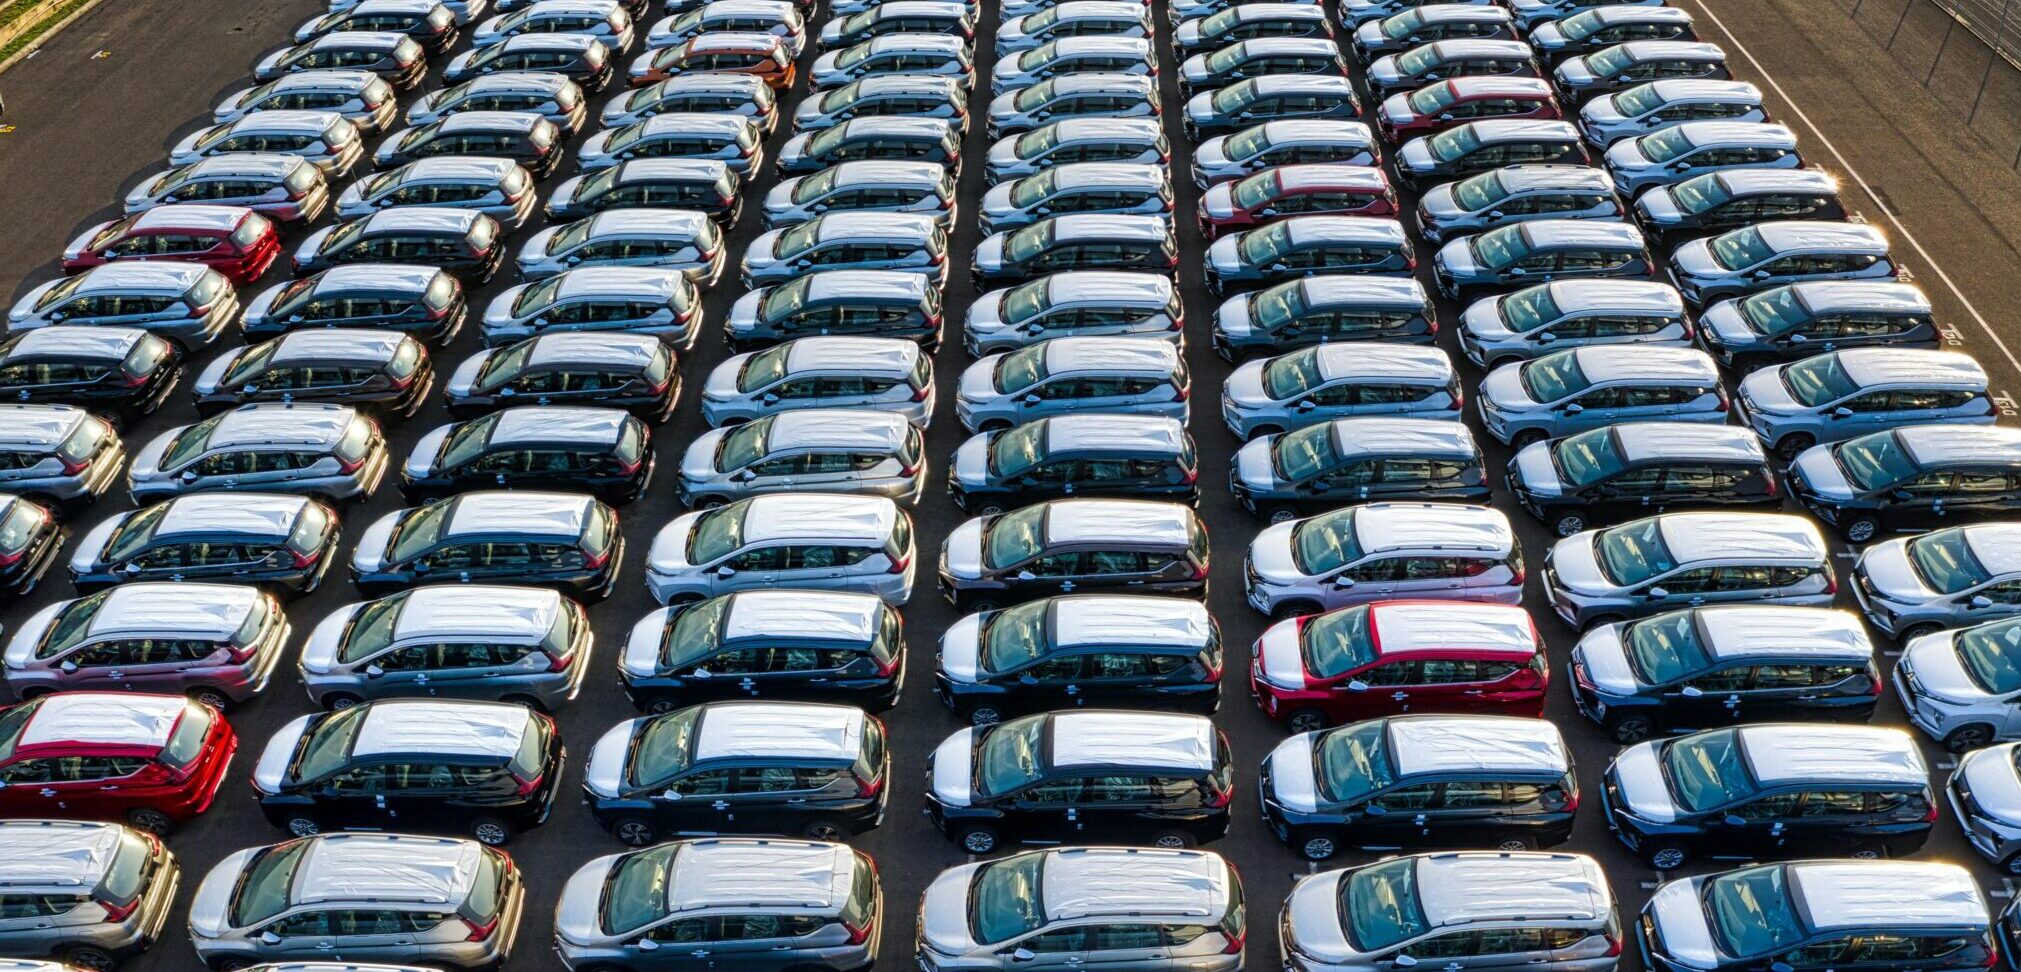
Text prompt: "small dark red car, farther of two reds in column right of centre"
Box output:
[[1200, 162, 1397, 238]]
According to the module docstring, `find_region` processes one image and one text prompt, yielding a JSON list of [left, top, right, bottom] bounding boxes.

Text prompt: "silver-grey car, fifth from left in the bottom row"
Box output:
[[1279, 851, 1621, 972]]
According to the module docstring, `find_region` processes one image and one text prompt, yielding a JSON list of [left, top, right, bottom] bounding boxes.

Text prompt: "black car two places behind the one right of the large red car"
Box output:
[[1508, 422, 1783, 538]]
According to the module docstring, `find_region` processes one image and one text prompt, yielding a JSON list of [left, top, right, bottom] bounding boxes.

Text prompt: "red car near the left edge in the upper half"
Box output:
[[63, 202, 281, 283]]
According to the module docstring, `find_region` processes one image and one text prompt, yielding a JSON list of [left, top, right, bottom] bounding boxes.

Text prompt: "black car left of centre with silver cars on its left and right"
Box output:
[[400, 404, 653, 503]]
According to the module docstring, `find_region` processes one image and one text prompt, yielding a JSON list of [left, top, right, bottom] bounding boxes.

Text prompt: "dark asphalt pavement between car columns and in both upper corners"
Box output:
[[0, 0, 2021, 972]]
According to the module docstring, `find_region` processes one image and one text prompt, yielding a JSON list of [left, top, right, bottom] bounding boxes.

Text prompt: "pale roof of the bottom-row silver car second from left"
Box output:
[[289, 835, 483, 905]]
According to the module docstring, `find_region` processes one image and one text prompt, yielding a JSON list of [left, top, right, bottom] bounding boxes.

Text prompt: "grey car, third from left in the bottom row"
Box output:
[[554, 837, 887, 972]]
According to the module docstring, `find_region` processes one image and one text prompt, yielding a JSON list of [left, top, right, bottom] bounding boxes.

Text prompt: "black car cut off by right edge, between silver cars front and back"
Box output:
[[1789, 424, 2021, 544]]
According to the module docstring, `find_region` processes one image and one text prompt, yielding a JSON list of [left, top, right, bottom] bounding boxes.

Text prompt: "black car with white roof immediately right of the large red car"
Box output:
[[1572, 604, 1882, 744]]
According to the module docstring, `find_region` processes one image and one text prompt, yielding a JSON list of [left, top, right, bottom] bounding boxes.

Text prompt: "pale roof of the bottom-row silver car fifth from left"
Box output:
[[1415, 851, 1615, 928]]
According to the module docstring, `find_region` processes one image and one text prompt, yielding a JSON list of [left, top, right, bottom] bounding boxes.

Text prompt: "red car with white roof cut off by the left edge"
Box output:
[[0, 691, 238, 835]]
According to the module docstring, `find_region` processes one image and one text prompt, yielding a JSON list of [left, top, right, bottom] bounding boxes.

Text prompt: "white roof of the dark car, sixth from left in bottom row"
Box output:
[[1785, 861, 1989, 932]]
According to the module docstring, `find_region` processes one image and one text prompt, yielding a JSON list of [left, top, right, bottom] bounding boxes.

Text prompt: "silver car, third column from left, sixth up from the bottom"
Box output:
[[701, 337, 934, 428]]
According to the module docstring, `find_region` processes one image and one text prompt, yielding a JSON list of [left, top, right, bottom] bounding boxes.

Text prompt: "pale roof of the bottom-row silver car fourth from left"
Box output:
[[1039, 847, 1235, 924]]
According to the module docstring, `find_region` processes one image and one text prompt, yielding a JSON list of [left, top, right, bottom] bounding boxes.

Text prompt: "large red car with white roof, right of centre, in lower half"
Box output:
[[1249, 600, 1550, 732]]
